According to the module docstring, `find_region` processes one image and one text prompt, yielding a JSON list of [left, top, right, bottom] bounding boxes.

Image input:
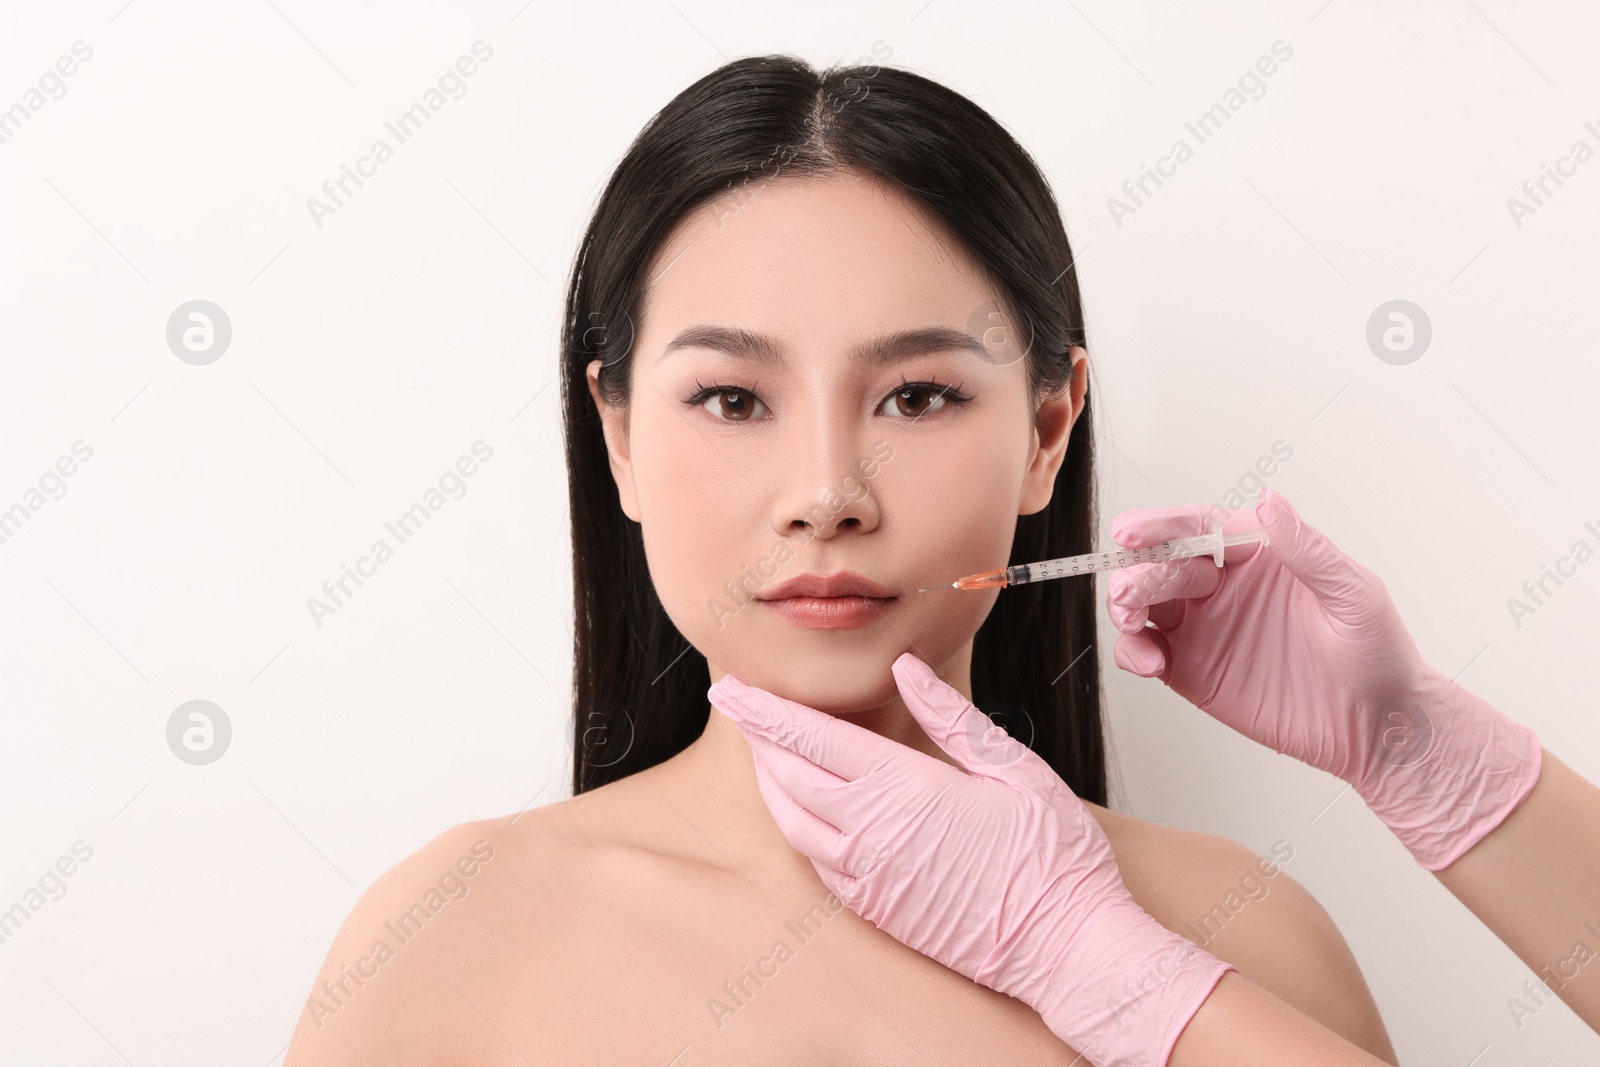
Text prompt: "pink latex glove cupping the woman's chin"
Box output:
[[707, 653, 1234, 1067]]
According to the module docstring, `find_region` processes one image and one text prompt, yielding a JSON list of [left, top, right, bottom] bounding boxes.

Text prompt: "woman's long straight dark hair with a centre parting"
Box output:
[[562, 51, 1106, 805]]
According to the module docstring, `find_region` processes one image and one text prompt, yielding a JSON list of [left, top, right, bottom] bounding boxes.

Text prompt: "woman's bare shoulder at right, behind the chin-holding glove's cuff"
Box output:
[[1090, 805, 1395, 1064]]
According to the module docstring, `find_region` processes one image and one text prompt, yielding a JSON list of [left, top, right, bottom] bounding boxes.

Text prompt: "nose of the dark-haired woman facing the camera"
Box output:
[[773, 414, 880, 541]]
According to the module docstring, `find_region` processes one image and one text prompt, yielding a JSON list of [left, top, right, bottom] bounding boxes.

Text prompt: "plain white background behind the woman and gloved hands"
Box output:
[[0, 0, 1600, 1067]]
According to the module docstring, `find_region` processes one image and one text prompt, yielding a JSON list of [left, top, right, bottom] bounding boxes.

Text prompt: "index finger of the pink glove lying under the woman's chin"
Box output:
[[706, 673, 902, 781]]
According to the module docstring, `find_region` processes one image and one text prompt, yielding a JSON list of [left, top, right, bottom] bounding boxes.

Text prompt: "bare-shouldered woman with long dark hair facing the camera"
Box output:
[[285, 56, 1587, 1067]]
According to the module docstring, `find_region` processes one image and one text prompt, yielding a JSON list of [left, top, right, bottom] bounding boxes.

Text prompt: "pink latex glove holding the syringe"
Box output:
[[1107, 488, 1541, 870]]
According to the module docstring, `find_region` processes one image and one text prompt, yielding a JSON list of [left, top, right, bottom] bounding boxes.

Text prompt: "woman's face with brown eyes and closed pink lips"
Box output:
[[589, 171, 1086, 713]]
